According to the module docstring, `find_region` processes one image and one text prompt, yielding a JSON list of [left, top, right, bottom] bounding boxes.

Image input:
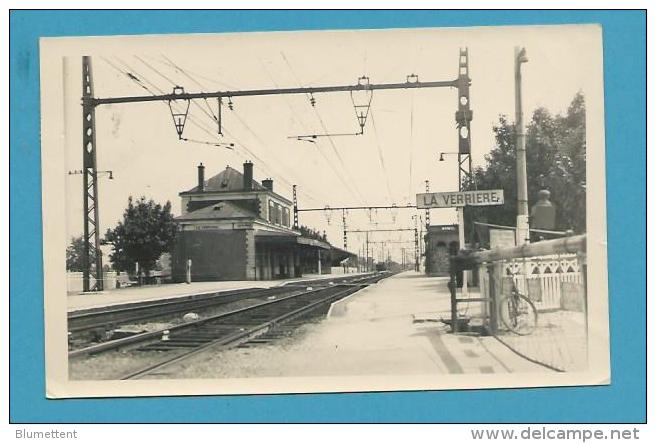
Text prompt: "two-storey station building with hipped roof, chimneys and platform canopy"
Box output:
[[171, 162, 344, 282]]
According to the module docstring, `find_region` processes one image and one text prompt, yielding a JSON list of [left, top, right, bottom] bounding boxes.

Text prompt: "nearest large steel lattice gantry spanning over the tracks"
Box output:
[[82, 48, 472, 291]]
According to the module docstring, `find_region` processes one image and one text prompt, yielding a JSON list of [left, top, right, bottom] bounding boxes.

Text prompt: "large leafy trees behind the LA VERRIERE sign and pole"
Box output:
[[463, 92, 586, 241]]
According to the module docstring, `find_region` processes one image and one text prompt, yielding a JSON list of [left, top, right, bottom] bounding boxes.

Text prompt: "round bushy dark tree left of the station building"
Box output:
[[105, 196, 176, 271]]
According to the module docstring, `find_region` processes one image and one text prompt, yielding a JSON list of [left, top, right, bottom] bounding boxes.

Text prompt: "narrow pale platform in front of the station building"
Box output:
[[67, 273, 374, 312]]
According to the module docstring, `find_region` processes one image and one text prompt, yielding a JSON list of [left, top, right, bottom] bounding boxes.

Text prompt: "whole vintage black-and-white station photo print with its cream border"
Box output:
[[40, 25, 610, 397]]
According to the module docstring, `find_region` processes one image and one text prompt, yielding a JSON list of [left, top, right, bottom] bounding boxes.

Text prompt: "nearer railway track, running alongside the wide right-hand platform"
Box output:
[[69, 273, 391, 379]]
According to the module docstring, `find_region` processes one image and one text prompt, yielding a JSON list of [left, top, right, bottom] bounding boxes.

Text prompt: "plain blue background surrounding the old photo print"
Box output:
[[10, 11, 646, 423]]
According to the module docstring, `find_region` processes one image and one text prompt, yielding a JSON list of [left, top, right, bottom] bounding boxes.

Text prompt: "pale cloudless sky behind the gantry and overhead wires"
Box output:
[[62, 26, 600, 261]]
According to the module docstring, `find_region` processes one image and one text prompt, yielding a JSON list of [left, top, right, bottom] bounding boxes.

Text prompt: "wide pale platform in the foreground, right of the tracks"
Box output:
[[169, 271, 548, 378]]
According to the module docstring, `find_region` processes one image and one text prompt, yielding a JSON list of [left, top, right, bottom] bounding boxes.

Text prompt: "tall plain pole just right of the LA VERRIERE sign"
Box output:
[[515, 47, 529, 246]]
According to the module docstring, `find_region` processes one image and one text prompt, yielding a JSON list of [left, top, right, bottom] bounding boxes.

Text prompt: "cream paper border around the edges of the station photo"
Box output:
[[40, 25, 610, 398]]
